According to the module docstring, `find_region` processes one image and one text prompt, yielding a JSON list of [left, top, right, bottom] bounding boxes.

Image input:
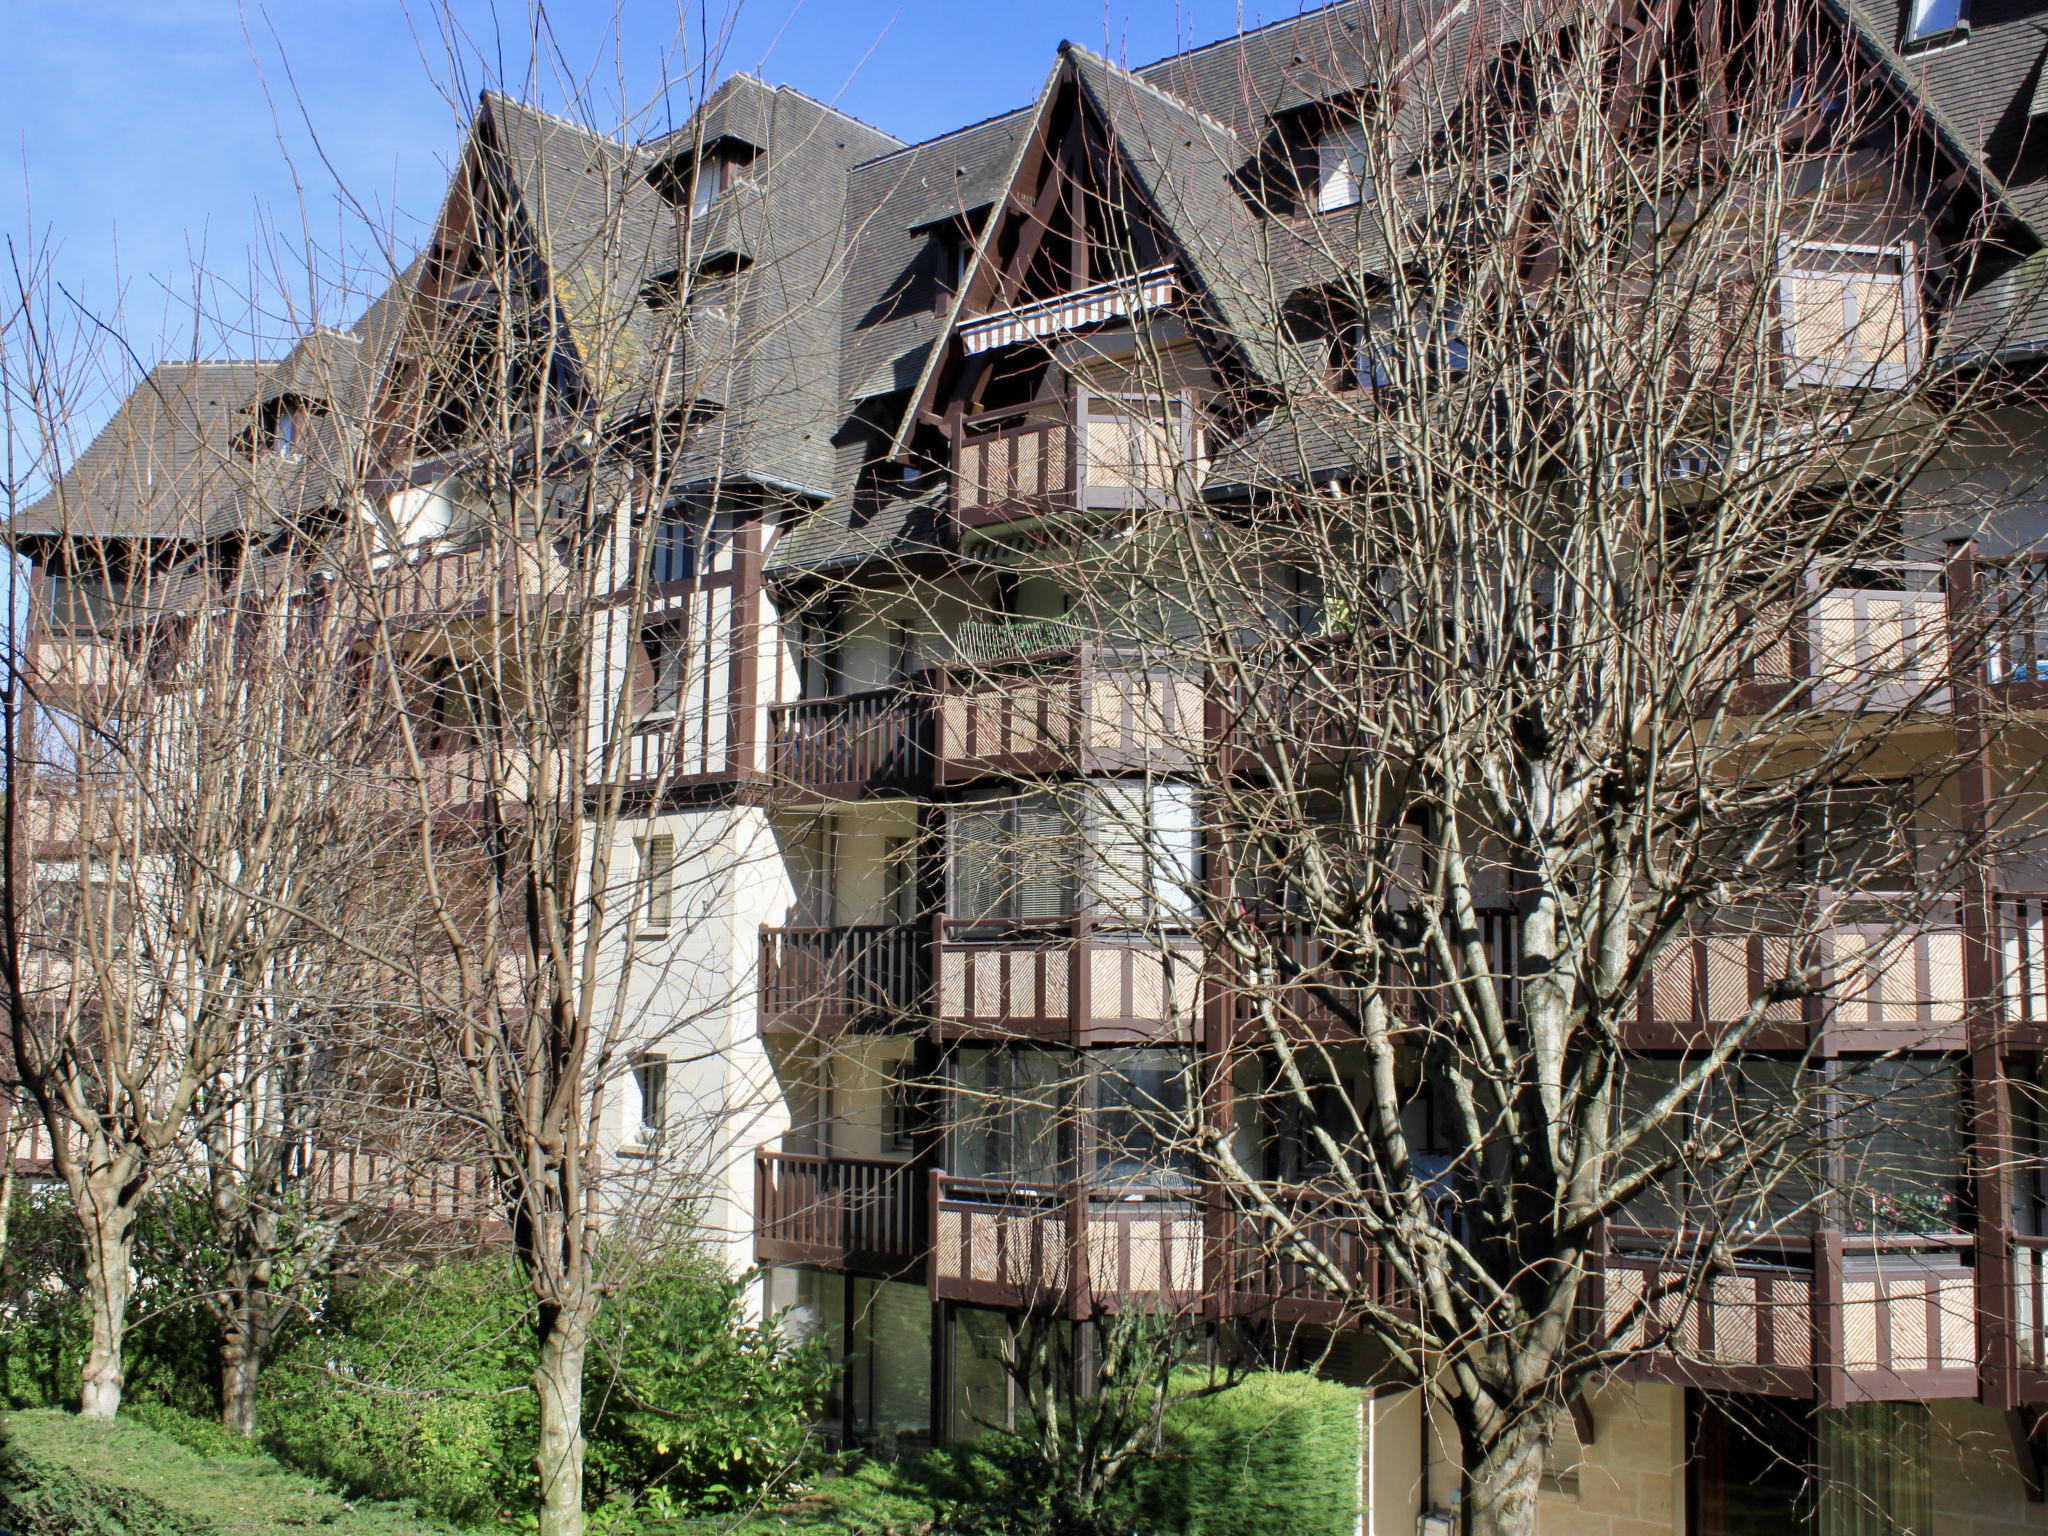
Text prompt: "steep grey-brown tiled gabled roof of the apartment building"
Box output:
[[32, 0, 2048, 573]]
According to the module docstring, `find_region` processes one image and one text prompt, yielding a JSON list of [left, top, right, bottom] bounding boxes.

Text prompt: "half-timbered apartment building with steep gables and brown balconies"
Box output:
[[14, 0, 2048, 1536]]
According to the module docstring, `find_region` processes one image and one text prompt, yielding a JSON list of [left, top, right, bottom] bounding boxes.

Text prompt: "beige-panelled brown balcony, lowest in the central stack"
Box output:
[[930, 1174, 1204, 1317]]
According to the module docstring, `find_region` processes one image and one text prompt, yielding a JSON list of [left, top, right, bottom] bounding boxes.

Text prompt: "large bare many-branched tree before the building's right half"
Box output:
[[794, 2, 2028, 1532]]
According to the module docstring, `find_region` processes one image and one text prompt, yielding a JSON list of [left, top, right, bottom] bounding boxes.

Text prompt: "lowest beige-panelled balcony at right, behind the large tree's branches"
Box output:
[[1593, 1229, 1978, 1403]]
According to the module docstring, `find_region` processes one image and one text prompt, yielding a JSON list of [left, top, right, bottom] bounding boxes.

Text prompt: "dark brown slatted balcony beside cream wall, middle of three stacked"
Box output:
[[760, 926, 932, 1034]]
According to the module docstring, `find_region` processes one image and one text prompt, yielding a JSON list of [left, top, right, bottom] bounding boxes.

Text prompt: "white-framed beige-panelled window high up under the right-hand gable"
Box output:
[[1778, 244, 1919, 389]]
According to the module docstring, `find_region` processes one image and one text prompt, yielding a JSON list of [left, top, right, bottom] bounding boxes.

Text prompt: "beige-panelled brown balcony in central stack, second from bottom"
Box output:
[[932, 918, 1202, 1047]]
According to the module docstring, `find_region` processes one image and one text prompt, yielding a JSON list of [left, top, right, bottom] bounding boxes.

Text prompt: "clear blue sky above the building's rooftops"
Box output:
[[0, 0, 1294, 372]]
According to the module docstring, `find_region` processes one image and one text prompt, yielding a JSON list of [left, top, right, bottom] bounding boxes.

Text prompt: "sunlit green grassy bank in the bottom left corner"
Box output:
[[0, 1411, 442, 1536]]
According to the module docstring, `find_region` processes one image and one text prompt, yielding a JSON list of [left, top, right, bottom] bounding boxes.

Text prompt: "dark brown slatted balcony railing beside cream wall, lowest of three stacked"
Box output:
[[754, 1147, 924, 1274]]
